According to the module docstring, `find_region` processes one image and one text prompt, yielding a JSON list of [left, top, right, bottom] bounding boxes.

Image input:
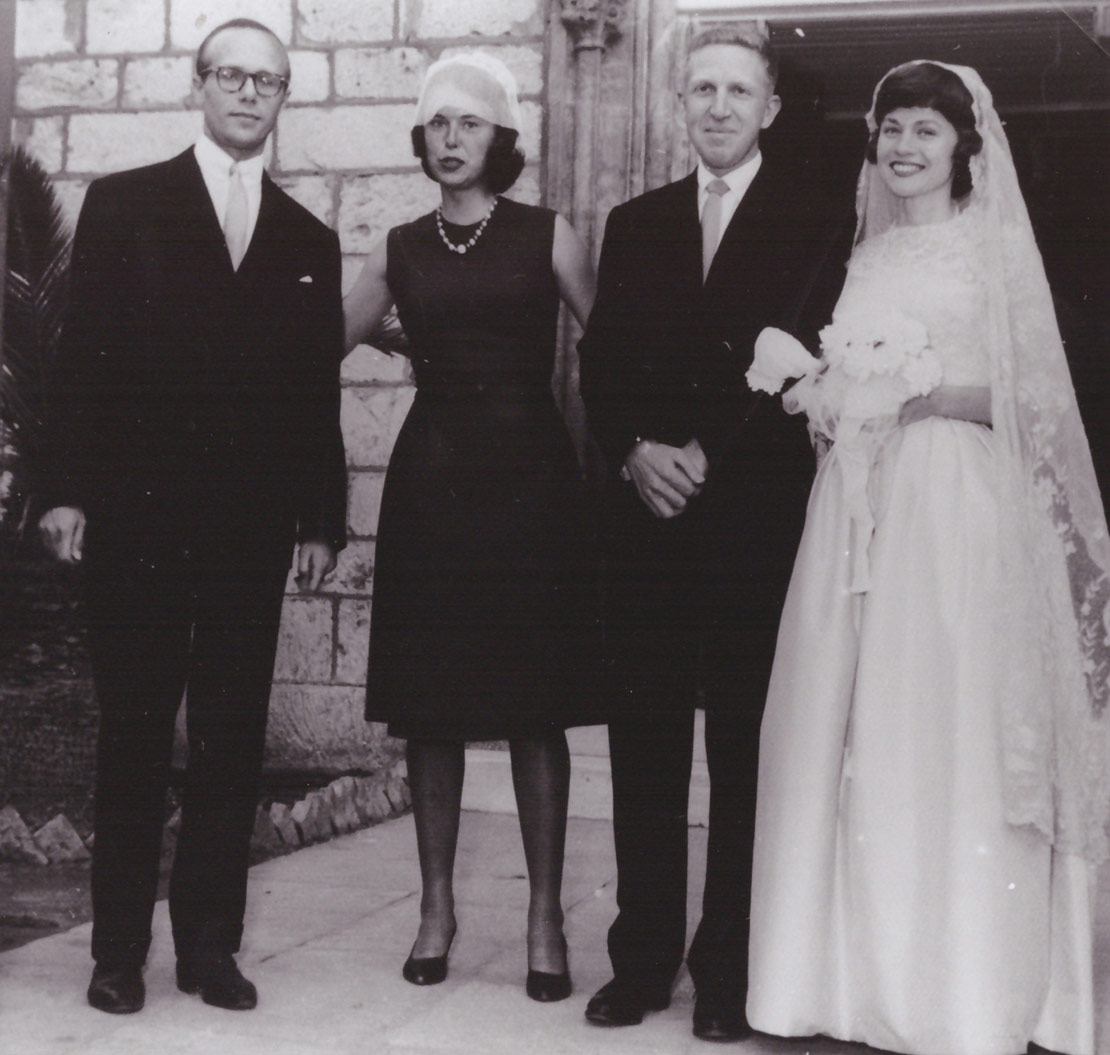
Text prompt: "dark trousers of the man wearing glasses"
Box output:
[[88, 544, 292, 964]]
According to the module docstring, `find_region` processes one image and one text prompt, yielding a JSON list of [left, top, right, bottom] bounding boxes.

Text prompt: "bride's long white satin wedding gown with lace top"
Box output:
[[747, 208, 1094, 1055]]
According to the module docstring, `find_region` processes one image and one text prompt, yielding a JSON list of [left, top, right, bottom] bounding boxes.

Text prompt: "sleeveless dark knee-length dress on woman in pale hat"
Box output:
[[366, 199, 603, 740]]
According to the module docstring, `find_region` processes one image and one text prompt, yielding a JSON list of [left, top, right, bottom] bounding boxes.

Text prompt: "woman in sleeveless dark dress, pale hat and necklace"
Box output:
[[344, 54, 601, 1001]]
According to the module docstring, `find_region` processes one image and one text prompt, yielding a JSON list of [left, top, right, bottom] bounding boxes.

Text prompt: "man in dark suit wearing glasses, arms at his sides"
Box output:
[[40, 20, 346, 1013]]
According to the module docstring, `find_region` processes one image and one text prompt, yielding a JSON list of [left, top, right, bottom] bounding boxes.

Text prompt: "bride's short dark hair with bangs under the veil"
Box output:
[[867, 62, 982, 199]]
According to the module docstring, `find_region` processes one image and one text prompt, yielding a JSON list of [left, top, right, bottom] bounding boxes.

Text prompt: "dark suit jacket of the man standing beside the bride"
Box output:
[[578, 163, 844, 595]]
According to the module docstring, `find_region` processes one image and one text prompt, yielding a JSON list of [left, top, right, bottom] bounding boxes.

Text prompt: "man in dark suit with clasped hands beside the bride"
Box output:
[[578, 28, 835, 1041]]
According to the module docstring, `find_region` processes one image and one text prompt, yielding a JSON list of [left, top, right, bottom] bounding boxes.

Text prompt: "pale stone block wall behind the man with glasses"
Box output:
[[12, 0, 548, 773]]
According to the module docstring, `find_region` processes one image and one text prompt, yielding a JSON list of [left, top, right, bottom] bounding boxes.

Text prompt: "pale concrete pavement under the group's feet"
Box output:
[[0, 812, 1110, 1055]]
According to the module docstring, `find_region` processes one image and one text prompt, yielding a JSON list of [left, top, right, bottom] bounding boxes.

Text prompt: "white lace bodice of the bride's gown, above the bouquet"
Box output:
[[833, 212, 990, 385]]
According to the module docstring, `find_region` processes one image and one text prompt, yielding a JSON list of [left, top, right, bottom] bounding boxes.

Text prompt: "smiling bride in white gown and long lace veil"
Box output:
[[747, 62, 1110, 1055]]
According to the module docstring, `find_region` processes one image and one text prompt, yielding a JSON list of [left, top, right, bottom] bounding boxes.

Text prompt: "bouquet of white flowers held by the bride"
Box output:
[[746, 304, 941, 439]]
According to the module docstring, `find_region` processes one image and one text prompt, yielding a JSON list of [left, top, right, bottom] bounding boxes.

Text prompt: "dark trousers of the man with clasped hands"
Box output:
[[607, 484, 789, 1002]]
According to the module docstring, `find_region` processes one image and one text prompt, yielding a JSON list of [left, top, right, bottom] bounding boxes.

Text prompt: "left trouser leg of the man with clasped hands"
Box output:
[[606, 499, 698, 991]]
